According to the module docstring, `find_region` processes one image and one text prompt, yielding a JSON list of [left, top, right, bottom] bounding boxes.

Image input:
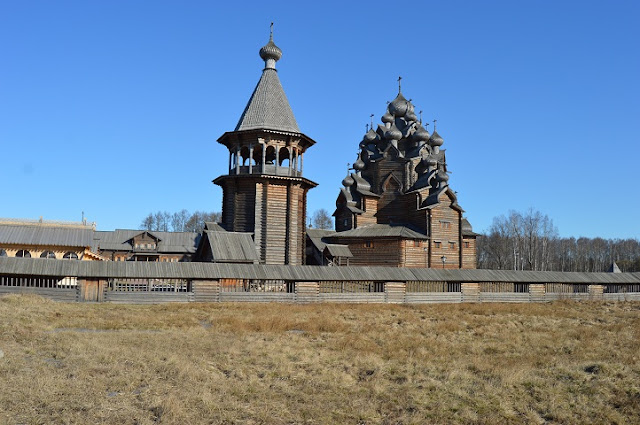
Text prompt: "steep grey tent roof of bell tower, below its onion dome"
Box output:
[[235, 68, 300, 133]]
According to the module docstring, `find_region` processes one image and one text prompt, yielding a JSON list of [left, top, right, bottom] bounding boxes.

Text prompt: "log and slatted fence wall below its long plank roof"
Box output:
[[0, 276, 640, 304]]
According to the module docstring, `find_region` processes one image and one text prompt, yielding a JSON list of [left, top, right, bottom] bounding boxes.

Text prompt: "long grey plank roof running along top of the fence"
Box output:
[[0, 257, 640, 285]]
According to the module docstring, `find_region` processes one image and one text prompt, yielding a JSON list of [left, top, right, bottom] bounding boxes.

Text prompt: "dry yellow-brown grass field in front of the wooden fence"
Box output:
[[0, 296, 640, 424]]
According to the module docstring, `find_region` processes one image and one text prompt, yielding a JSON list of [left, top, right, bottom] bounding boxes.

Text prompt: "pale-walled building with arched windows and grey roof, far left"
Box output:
[[0, 219, 104, 261]]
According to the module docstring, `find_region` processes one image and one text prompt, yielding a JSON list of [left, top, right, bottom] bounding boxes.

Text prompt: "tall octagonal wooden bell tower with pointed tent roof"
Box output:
[[214, 26, 317, 265]]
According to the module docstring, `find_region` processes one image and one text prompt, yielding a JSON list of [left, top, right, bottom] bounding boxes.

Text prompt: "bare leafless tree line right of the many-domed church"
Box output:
[[477, 209, 640, 272]]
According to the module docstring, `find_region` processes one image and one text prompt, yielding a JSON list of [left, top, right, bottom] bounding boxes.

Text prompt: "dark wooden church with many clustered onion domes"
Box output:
[[322, 83, 476, 268]]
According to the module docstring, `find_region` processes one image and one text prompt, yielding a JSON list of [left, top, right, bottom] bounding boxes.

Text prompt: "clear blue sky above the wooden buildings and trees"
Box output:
[[0, 0, 640, 238]]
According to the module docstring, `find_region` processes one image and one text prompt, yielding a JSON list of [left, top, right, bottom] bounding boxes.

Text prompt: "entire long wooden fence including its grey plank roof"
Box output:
[[0, 257, 640, 304]]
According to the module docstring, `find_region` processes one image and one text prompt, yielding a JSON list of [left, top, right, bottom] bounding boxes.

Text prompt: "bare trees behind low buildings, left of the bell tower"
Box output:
[[140, 210, 220, 232]]
